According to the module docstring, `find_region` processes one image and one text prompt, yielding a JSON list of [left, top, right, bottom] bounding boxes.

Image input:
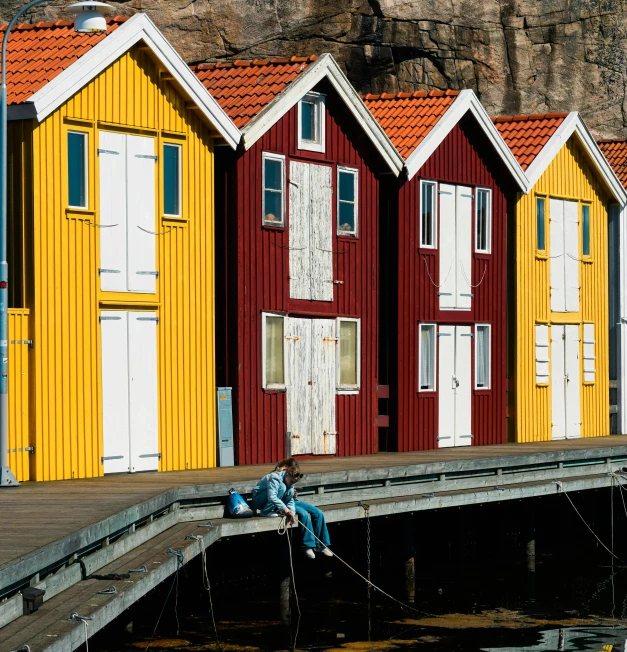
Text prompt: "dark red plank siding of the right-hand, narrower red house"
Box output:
[[398, 116, 513, 451]]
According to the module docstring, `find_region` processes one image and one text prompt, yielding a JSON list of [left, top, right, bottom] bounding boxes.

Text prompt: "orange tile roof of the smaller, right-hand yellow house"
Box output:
[[494, 113, 568, 170]]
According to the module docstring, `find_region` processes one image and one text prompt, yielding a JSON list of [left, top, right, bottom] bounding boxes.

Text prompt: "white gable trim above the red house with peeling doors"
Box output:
[[242, 54, 403, 176]]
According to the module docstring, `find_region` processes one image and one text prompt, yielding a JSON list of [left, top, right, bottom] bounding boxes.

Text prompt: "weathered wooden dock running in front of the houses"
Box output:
[[0, 436, 627, 652]]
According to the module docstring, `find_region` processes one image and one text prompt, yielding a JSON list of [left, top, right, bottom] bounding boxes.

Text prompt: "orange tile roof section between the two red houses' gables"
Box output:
[[363, 91, 459, 159]]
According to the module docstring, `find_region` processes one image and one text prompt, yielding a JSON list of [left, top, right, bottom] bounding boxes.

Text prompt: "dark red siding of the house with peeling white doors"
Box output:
[[221, 84, 384, 464]]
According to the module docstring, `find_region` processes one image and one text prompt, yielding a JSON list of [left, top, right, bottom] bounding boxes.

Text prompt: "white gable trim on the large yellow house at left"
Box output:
[[28, 14, 241, 149]]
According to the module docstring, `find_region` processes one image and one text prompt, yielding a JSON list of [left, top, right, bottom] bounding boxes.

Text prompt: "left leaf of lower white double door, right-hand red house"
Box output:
[[437, 326, 456, 448]]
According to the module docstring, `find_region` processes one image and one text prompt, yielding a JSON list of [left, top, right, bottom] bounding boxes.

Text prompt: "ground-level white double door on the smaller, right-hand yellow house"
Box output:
[[551, 324, 581, 439]]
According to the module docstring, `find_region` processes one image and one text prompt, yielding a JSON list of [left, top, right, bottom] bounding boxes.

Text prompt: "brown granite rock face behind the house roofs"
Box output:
[[0, 0, 627, 137]]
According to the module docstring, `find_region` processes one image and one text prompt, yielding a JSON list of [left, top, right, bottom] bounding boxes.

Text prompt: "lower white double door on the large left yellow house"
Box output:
[[100, 310, 160, 473]]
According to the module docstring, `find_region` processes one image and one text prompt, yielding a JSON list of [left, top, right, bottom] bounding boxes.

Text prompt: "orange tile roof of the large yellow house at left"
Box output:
[[0, 16, 127, 104]]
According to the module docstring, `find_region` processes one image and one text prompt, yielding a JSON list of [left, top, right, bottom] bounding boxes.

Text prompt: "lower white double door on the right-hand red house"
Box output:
[[437, 326, 473, 448]]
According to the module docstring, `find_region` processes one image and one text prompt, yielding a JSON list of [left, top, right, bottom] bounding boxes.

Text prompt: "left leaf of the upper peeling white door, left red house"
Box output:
[[289, 161, 311, 300]]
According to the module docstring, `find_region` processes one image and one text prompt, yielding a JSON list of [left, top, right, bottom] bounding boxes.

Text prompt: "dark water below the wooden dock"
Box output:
[[89, 492, 627, 652]]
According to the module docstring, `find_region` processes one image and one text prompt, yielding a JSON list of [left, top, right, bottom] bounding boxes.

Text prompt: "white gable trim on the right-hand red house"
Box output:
[[405, 90, 527, 192]]
